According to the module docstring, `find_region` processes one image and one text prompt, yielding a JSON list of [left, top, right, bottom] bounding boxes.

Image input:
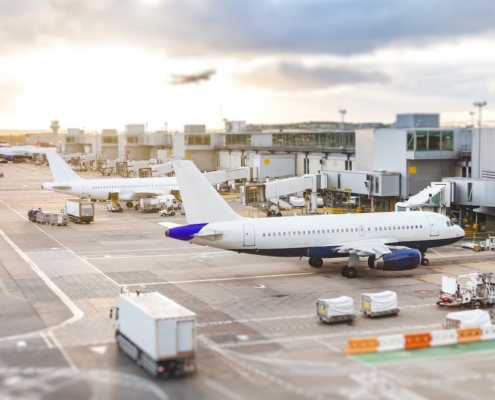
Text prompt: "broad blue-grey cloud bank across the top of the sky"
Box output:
[[0, 0, 495, 57]]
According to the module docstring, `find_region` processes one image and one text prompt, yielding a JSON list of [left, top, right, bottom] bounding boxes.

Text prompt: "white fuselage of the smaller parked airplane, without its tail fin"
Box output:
[[42, 177, 179, 201]]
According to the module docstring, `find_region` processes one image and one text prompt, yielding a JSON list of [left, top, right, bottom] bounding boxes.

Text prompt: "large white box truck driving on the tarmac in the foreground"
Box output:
[[110, 290, 196, 378]]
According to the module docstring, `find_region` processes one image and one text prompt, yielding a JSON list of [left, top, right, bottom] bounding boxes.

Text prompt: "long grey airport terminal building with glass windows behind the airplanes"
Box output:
[[35, 114, 495, 229]]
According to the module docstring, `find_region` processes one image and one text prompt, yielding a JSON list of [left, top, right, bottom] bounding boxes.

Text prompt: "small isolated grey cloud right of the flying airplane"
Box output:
[[235, 62, 390, 92]]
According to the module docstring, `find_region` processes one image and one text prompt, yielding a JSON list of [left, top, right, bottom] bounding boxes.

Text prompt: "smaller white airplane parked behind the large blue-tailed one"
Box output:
[[41, 151, 179, 208]]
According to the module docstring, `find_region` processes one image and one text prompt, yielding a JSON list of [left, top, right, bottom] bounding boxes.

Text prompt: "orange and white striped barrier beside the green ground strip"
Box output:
[[344, 325, 495, 354]]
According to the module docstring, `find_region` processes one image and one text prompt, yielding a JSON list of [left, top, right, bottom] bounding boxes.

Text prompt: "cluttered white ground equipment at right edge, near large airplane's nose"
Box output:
[[437, 272, 495, 309]]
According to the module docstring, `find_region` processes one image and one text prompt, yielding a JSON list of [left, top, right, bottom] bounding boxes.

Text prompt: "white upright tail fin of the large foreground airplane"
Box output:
[[173, 160, 242, 224]]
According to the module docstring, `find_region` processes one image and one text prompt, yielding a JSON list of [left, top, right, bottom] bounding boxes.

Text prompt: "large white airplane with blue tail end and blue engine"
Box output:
[[162, 161, 464, 278]]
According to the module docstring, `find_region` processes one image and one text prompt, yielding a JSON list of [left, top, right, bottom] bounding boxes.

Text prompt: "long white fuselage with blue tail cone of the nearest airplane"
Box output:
[[167, 212, 464, 258]]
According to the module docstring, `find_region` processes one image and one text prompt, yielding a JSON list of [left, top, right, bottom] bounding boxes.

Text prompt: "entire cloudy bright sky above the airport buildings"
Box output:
[[0, 0, 495, 132]]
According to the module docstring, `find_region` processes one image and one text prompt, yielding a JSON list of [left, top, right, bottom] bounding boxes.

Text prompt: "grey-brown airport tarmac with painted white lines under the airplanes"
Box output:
[[0, 164, 495, 400]]
